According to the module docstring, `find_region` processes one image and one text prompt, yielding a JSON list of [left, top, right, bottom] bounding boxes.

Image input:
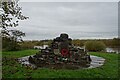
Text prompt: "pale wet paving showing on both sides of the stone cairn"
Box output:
[[18, 55, 105, 69]]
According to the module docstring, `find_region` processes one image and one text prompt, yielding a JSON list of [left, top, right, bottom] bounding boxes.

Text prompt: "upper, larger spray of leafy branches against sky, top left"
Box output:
[[1, 1, 28, 36]]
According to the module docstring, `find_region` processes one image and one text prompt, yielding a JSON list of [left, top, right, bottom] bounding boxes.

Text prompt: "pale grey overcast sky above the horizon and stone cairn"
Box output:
[[18, 2, 118, 40]]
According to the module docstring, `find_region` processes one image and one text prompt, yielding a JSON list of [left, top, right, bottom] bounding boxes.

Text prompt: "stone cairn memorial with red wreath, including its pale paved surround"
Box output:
[[18, 33, 105, 69]]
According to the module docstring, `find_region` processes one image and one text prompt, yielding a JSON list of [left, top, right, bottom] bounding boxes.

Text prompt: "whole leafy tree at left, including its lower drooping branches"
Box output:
[[0, 0, 28, 50]]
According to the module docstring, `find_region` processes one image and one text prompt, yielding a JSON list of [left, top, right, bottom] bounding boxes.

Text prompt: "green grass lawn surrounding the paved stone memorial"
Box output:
[[2, 50, 119, 78]]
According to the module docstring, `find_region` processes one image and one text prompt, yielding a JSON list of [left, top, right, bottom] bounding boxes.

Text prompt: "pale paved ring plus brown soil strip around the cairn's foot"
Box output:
[[18, 55, 105, 70]]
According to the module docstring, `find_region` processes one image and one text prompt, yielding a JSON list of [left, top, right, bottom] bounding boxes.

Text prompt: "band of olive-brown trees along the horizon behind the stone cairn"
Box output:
[[2, 38, 120, 51]]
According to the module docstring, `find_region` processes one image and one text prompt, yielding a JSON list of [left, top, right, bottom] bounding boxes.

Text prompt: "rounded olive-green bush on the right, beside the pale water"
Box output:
[[85, 41, 106, 52]]
